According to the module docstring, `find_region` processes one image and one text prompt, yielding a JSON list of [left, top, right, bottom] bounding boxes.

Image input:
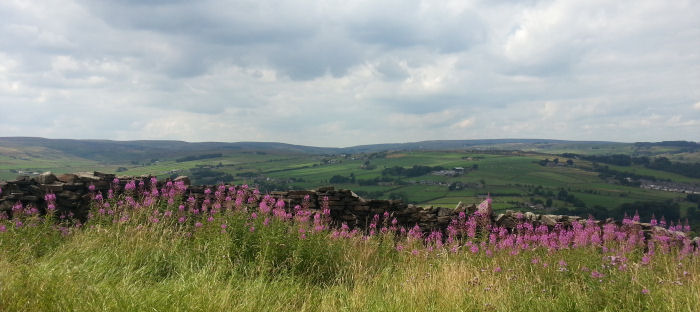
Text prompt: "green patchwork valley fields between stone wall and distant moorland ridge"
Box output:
[[0, 143, 700, 227]]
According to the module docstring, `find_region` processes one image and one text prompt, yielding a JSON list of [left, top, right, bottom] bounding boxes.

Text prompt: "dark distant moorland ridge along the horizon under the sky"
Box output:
[[0, 137, 700, 163]]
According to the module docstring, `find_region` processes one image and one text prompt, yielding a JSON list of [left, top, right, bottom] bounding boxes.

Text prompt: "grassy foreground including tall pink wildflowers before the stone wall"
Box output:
[[0, 182, 700, 311]]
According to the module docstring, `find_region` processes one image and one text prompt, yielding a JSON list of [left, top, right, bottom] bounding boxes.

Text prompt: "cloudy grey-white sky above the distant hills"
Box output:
[[0, 0, 700, 147]]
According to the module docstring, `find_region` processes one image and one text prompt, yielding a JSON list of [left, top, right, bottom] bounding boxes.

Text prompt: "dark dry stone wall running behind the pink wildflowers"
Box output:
[[0, 172, 700, 246]]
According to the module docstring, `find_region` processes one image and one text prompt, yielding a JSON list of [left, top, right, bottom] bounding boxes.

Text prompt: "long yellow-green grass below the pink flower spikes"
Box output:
[[0, 205, 700, 311]]
